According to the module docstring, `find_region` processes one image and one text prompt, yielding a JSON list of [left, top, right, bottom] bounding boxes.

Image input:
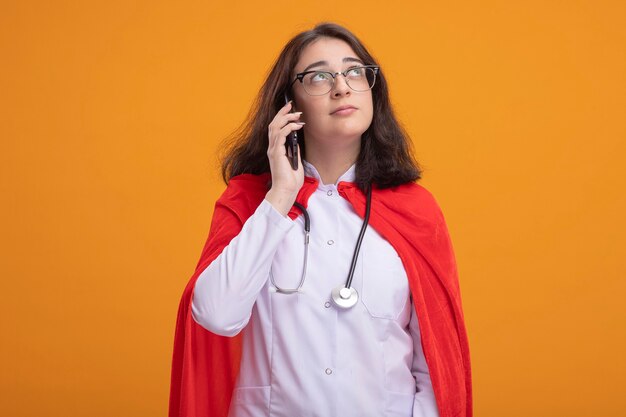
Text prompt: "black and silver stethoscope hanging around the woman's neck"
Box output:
[[270, 186, 372, 309]]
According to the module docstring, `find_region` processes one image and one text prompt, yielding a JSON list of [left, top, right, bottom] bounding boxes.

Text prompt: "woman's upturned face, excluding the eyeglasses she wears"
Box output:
[[293, 38, 373, 148]]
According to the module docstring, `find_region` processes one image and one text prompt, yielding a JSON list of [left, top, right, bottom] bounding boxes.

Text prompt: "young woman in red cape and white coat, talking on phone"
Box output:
[[170, 24, 472, 417]]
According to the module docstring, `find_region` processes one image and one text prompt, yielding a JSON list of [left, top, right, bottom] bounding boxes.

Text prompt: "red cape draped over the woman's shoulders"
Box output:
[[169, 174, 472, 417]]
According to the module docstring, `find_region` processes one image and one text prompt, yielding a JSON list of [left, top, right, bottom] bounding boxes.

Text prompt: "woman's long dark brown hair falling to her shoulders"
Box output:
[[221, 23, 421, 190]]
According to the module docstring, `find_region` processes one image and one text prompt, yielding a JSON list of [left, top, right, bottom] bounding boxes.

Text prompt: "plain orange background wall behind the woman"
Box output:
[[0, 0, 626, 417]]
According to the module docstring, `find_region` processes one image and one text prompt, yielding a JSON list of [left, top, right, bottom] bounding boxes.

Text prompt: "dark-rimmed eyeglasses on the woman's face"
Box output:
[[289, 65, 380, 96]]
